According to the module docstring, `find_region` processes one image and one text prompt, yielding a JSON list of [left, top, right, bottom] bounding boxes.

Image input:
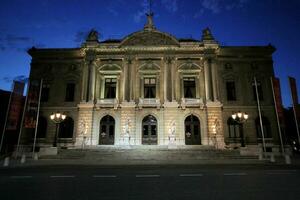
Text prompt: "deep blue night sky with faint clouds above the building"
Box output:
[[0, 0, 300, 106]]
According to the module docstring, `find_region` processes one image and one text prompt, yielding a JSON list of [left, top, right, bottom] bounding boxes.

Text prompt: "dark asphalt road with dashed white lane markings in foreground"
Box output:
[[0, 165, 300, 200]]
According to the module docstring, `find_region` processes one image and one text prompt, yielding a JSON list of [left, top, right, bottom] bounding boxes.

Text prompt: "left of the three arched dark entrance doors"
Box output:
[[99, 115, 115, 145]]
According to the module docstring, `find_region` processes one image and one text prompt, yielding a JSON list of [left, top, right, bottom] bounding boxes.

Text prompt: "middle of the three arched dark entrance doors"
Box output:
[[142, 115, 157, 145]]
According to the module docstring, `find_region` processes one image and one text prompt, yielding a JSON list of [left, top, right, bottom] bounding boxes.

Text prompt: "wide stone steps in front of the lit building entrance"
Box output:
[[50, 148, 257, 160]]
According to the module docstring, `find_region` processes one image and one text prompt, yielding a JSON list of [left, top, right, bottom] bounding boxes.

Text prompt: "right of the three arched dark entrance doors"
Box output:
[[184, 115, 201, 145]]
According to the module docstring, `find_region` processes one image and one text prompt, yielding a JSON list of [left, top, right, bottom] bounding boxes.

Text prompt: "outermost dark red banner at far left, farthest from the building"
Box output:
[[6, 81, 25, 130]]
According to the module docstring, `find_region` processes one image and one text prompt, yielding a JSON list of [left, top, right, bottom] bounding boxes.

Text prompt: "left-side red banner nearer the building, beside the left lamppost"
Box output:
[[24, 80, 40, 128]]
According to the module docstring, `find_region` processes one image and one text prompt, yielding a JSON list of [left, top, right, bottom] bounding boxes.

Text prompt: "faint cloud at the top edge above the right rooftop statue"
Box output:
[[194, 0, 250, 18]]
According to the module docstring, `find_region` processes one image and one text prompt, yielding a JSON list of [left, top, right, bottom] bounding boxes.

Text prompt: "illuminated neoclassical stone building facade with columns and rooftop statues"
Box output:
[[29, 14, 277, 148]]
